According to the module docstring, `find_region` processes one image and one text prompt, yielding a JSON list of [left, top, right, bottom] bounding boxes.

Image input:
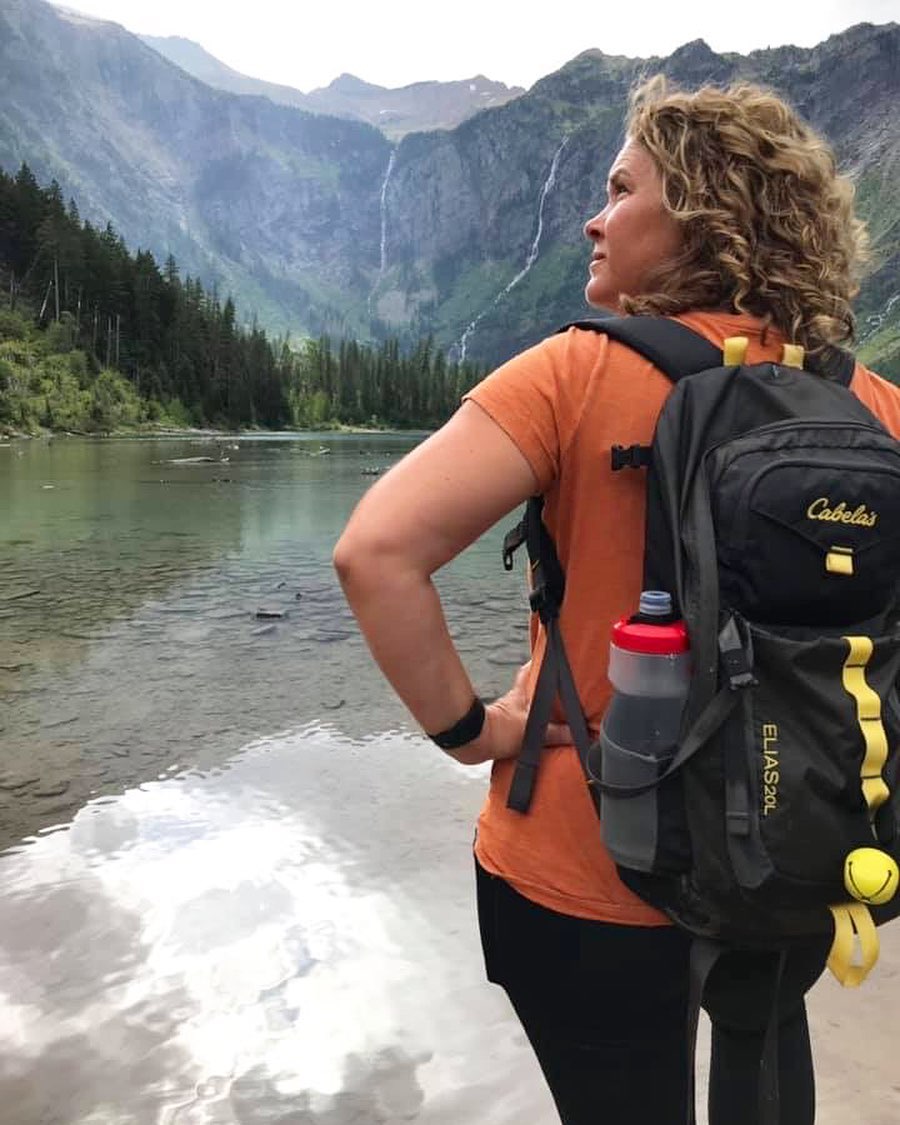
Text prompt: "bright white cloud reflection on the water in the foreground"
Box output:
[[0, 726, 554, 1125]]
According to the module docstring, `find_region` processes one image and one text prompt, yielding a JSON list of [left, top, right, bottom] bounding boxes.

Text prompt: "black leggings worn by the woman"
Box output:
[[476, 864, 829, 1125]]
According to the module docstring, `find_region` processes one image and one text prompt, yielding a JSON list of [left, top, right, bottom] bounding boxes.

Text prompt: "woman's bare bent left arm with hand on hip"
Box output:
[[334, 402, 567, 763]]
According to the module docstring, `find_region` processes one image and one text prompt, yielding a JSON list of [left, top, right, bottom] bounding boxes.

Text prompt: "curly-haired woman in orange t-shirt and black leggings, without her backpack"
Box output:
[[335, 79, 900, 1125]]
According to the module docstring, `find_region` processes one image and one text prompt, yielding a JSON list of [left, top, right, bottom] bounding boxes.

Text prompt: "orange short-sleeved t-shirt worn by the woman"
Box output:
[[467, 313, 900, 926]]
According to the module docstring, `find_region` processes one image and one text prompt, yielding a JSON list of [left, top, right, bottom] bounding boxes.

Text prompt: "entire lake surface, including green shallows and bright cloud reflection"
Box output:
[[0, 435, 554, 1125]]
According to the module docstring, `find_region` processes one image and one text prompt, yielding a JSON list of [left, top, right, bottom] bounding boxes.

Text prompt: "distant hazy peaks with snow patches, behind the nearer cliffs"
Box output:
[[141, 35, 524, 141]]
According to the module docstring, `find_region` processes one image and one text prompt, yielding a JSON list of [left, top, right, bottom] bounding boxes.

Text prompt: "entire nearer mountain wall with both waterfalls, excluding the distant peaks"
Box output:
[[0, 0, 900, 379]]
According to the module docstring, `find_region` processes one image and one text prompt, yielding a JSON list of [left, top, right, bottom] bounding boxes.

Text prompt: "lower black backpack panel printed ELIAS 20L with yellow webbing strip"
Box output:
[[729, 628, 900, 908]]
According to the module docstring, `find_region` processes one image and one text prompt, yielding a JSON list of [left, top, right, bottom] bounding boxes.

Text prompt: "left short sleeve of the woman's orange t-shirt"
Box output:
[[464, 329, 606, 492]]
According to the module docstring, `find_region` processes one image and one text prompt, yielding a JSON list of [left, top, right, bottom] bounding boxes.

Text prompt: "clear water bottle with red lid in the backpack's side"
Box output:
[[595, 590, 691, 872]]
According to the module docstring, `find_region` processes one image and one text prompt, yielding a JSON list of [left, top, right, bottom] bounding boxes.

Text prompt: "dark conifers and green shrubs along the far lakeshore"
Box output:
[[0, 164, 479, 432]]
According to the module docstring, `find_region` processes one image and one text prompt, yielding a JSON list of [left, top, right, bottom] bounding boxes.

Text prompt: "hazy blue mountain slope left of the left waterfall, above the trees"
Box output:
[[0, 0, 390, 333]]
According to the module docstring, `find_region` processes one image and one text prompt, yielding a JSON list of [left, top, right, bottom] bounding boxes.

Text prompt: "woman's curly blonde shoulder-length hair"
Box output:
[[622, 75, 867, 351]]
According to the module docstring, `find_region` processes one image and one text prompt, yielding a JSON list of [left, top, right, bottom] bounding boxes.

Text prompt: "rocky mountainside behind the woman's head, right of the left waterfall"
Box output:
[[387, 25, 900, 377]]
